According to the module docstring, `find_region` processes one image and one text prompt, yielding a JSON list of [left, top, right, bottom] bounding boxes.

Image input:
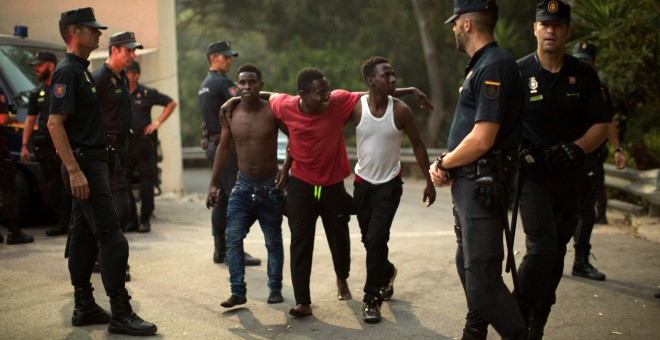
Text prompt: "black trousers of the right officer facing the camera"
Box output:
[[514, 167, 588, 314]]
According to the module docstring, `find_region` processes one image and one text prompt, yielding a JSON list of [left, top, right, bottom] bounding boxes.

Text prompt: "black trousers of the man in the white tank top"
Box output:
[[353, 177, 403, 301]]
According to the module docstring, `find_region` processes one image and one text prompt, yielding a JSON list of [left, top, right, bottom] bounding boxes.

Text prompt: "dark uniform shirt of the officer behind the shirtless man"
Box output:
[[198, 71, 238, 134]]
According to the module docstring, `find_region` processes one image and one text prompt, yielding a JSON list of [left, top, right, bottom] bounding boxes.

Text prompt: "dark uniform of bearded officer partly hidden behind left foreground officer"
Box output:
[[27, 83, 71, 233]]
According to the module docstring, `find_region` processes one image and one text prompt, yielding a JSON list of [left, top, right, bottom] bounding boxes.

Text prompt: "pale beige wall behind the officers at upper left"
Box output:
[[0, 0, 183, 194]]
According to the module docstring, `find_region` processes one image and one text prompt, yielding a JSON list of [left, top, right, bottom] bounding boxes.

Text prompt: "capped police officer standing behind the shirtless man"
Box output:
[[199, 41, 261, 266]]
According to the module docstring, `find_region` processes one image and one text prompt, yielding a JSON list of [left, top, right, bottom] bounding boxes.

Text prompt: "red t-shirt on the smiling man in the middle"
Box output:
[[270, 90, 360, 186]]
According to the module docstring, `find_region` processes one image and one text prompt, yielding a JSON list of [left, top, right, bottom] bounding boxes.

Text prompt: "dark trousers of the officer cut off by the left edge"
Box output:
[[0, 135, 19, 232]]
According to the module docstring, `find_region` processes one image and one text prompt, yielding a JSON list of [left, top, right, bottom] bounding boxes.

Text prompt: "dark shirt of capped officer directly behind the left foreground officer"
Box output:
[[93, 64, 132, 135]]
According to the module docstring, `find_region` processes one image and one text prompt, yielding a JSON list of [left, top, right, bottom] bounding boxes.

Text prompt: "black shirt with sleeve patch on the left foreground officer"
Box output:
[[50, 53, 106, 149]]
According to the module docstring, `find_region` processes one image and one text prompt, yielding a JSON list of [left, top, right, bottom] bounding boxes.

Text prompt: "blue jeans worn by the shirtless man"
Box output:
[[225, 172, 284, 297]]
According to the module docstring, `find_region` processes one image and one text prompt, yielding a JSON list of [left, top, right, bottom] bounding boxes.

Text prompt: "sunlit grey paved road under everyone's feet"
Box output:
[[0, 170, 660, 339]]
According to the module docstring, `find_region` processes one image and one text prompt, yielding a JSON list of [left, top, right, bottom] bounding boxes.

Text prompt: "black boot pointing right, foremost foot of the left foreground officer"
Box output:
[[108, 293, 158, 336]]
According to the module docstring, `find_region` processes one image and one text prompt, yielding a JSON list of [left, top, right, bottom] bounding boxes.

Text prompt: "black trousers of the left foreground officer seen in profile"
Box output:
[[62, 161, 128, 298]]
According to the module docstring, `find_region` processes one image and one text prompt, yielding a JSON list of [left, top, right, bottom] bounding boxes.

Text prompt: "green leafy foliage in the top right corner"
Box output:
[[573, 0, 660, 163]]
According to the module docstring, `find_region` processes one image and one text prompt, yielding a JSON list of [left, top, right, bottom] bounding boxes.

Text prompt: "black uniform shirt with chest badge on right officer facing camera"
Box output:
[[518, 53, 611, 149]]
